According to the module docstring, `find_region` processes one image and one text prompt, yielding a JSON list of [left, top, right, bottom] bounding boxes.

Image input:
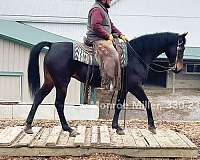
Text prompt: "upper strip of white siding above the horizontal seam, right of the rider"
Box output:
[[110, 0, 200, 17]]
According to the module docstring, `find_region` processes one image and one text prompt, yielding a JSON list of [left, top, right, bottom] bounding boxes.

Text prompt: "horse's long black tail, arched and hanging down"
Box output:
[[28, 42, 52, 97]]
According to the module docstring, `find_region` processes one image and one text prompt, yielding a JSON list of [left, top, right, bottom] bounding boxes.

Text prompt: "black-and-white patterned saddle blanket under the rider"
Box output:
[[73, 41, 128, 67]]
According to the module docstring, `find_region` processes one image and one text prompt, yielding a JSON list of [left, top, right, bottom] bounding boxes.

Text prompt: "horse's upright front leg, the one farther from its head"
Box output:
[[112, 91, 127, 135]]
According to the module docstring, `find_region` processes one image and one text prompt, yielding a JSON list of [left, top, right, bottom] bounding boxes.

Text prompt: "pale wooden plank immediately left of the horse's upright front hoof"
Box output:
[[100, 125, 110, 145]]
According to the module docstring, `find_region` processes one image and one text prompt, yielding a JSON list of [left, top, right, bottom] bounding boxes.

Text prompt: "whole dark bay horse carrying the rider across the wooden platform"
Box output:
[[25, 32, 187, 136]]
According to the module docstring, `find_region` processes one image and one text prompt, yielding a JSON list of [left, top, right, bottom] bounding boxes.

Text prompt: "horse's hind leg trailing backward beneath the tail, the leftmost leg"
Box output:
[[24, 72, 54, 134]]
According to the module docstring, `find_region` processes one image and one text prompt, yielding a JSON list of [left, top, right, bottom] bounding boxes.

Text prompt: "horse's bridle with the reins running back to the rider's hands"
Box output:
[[126, 39, 185, 72]]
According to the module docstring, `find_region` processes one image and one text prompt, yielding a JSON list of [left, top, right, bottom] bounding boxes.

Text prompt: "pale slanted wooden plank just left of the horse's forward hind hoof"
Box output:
[[46, 126, 62, 147]]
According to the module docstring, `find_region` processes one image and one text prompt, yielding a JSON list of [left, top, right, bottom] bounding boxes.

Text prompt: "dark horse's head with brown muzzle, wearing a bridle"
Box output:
[[165, 33, 187, 73]]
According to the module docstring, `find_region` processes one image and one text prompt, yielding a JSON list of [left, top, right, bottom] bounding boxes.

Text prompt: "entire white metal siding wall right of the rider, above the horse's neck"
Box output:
[[110, 0, 200, 47]]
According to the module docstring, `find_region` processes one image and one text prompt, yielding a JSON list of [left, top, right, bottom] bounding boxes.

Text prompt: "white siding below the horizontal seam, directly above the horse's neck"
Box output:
[[112, 16, 200, 47]]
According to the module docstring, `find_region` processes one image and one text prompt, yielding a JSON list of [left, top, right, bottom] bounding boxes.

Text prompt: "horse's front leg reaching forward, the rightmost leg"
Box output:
[[129, 85, 156, 134]]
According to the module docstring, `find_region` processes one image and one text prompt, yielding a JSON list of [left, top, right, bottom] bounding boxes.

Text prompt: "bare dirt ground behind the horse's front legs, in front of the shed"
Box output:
[[97, 88, 200, 121]]
